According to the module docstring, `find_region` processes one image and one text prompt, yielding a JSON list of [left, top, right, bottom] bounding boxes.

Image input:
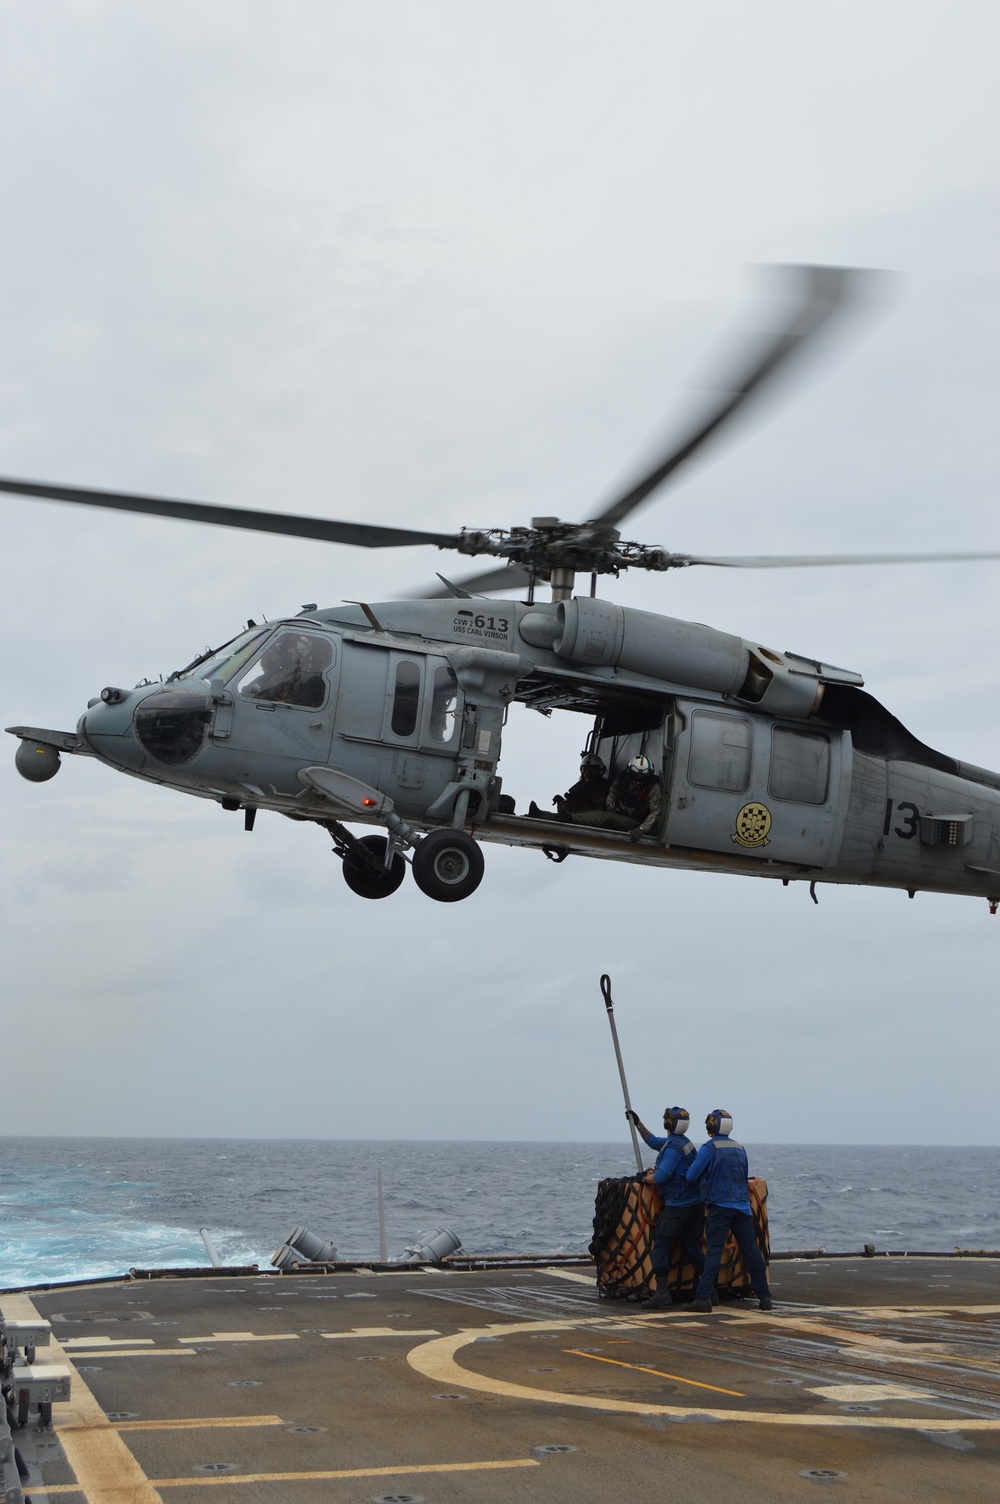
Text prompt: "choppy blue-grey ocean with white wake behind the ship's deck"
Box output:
[[0, 1139, 1000, 1289]]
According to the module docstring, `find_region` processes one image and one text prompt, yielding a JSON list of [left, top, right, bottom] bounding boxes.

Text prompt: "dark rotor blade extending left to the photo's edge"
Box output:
[[0, 480, 459, 549]]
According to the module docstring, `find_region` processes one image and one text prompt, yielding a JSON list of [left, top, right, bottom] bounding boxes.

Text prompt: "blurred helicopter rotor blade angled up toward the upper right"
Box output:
[[591, 266, 880, 526]]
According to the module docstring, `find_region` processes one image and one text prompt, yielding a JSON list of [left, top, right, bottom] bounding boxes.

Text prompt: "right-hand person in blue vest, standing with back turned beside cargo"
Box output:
[[687, 1107, 771, 1313]]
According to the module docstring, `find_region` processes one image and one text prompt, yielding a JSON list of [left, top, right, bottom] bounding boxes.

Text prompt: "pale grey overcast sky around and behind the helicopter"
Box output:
[[0, 0, 1000, 1143]]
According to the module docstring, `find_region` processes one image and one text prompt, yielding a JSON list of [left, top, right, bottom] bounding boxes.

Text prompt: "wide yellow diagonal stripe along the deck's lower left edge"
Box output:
[[3, 1295, 162, 1504]]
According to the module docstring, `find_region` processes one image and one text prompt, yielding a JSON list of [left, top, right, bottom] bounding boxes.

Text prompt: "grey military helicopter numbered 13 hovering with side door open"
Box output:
[[0, 268, 1000, 913]]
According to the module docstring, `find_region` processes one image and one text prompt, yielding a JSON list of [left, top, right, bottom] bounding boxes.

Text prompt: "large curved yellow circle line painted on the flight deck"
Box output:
[[406, 1313, 1000, 1432]]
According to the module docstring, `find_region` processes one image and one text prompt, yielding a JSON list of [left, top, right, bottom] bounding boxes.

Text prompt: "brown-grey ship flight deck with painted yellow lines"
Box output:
[[0, 1257, 1000, 1504]]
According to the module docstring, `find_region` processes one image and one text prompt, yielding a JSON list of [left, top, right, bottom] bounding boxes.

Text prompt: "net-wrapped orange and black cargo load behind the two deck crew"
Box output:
[[589, 1175, 771, 1301]]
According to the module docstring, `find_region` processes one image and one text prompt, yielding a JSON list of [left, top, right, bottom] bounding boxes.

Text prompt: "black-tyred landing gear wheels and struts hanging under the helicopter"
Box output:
[[323, 820, 484, 904]]
